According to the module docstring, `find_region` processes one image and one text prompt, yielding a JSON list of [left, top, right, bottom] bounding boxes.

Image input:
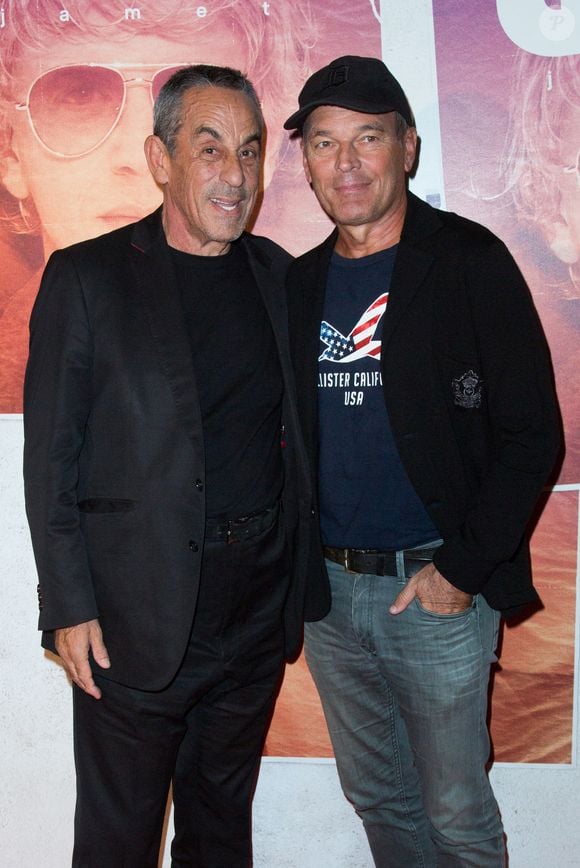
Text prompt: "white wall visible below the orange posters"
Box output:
[[0, 417, 580, 868]]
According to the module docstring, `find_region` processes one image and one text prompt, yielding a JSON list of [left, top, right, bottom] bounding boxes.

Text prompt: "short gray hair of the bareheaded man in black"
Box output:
[[153, 63, 264, 154]]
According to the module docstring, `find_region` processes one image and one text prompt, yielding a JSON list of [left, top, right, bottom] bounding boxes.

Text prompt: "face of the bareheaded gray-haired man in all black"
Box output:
[[146, 86, 261, 256]]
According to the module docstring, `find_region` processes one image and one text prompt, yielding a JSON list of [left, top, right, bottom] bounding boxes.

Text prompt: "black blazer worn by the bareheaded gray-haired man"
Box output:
[[24, 211, 324, 689]]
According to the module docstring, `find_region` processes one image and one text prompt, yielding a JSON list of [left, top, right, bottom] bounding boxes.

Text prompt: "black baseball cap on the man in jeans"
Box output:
[[284, 55, 415, 130]]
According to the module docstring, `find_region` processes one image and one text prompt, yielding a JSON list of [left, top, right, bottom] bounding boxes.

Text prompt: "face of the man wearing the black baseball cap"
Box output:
[[303, 106, 417, 252]]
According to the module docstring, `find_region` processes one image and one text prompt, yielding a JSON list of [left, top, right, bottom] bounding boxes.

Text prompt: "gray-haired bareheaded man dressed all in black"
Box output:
[[25, 66, 322, 868]]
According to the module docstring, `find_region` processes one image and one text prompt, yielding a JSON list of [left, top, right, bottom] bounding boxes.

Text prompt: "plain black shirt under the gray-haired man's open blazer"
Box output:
[[171, 243, 283, 518]]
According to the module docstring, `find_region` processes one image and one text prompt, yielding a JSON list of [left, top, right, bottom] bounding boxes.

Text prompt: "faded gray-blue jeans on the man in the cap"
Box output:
[[306, 561, 505, 868]]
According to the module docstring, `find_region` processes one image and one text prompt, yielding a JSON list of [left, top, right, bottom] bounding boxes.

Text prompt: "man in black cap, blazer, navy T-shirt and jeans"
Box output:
[[286, 57, 559, 868]]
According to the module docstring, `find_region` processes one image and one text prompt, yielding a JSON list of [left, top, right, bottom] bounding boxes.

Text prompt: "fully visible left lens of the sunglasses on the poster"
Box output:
[[29, 66, 125, 157]]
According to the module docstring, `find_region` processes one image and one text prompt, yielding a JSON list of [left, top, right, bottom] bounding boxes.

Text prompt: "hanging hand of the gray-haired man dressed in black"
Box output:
[[54, 619, 111, 699]]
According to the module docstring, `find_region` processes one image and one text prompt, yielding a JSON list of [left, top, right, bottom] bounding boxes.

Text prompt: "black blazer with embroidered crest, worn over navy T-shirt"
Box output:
[[288, 194, 561, 614]]
